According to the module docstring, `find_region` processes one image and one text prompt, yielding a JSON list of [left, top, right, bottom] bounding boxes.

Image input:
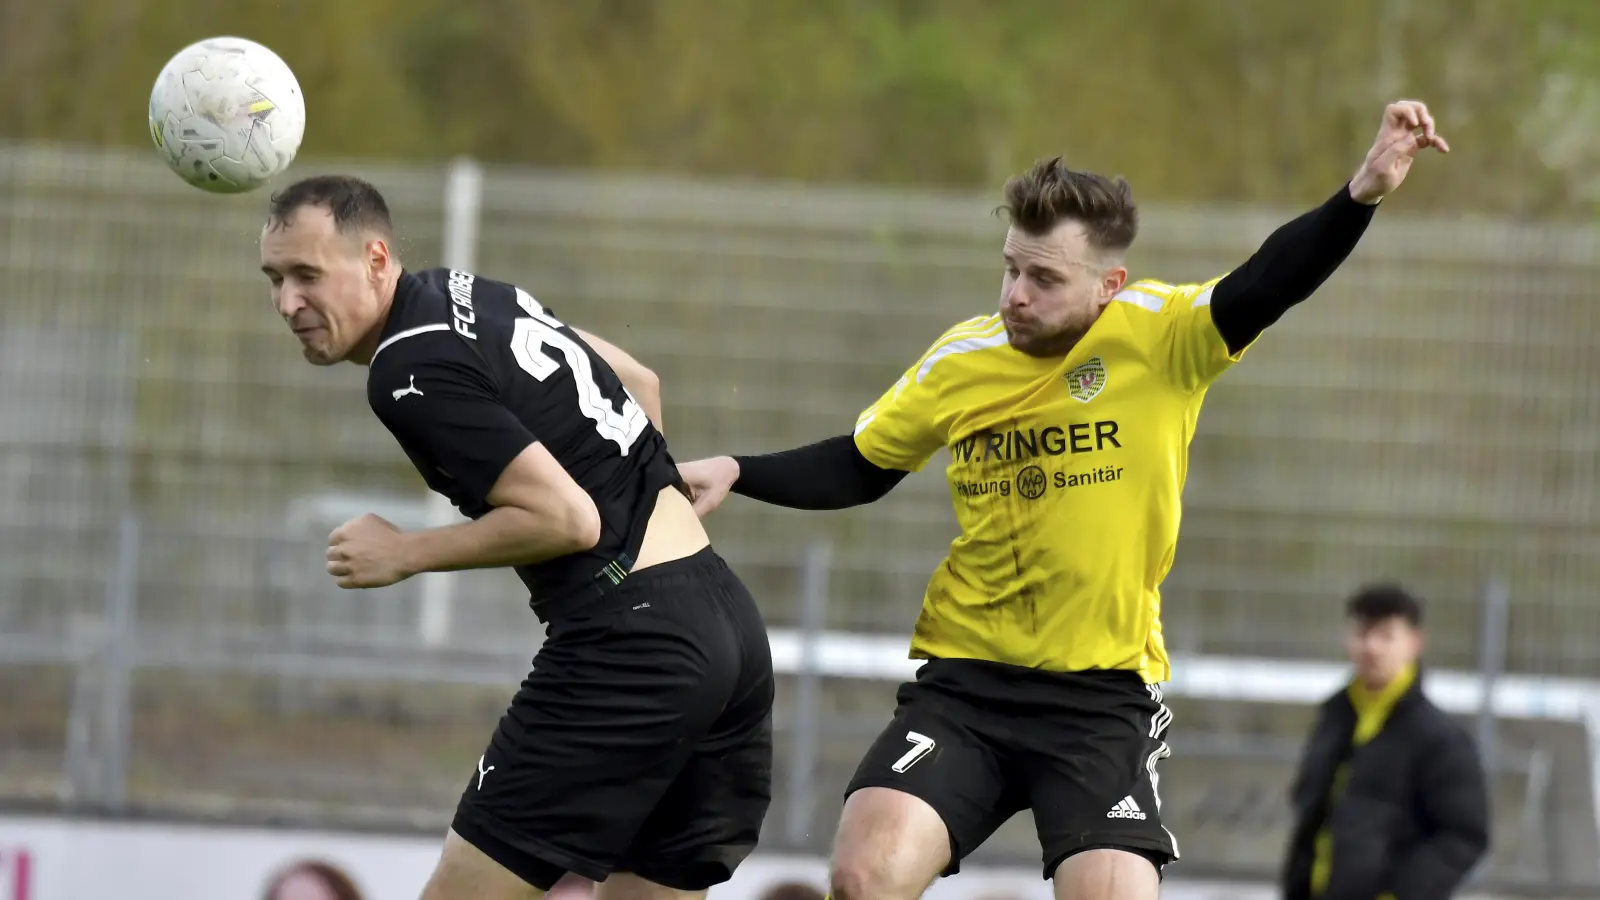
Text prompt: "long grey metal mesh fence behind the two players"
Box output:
[[0, 146, 1600, 881]]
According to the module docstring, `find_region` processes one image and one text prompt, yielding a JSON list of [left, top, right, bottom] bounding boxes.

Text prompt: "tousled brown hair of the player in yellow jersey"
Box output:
[[1000, 157, 1139, 251]]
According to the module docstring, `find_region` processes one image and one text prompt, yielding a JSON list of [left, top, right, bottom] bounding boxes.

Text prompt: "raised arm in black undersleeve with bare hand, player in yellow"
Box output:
[[1210, 101, 1450, 354]]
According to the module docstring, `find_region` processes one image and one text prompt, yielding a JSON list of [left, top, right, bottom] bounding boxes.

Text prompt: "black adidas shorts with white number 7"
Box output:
[[846, 650, 1178, 879]]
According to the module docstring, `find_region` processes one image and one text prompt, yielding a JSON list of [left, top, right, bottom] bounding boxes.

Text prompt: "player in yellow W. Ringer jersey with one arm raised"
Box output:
[[680, 101, 1448, 900]]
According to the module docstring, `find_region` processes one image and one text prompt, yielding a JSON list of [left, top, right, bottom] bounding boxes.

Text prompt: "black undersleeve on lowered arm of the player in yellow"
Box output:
[[733, 434, 910, 509]]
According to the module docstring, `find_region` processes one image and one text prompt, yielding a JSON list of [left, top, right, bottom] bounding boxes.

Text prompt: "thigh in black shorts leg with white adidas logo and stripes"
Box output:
[[1019, 684, 1178, 877]]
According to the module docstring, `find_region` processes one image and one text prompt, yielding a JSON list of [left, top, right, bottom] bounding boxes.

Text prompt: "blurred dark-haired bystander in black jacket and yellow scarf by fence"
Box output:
[[1282, 585, 1490, 900]]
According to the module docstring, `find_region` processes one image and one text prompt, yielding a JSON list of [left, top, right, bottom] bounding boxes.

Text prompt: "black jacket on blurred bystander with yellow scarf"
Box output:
[[1282, 676, 1490, 900]]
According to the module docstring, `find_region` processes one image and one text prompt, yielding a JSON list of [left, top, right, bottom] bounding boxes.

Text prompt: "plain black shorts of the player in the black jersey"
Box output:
[[451, 548, 774, 890]]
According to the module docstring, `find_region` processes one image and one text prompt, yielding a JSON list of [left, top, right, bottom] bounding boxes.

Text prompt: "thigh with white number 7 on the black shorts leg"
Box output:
[[834, 682, 1022, 897]]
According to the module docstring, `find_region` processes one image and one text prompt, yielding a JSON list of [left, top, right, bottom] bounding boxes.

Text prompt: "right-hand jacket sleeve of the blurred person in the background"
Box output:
[[1392, 729, 1490, 900]]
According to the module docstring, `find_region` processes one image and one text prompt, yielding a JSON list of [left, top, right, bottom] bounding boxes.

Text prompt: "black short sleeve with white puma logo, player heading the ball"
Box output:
[[366, 331, 538, 501]]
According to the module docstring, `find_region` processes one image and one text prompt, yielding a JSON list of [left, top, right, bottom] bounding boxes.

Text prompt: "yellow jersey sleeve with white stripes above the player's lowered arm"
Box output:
[[856, 315, 1003, 472]]
